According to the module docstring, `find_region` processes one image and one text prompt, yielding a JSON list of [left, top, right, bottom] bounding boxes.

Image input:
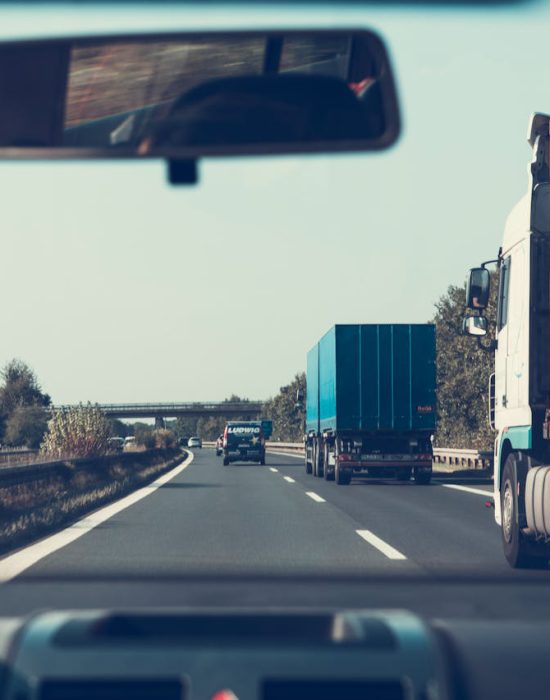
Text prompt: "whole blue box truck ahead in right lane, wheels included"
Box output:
[[304, 324, 436, 484]]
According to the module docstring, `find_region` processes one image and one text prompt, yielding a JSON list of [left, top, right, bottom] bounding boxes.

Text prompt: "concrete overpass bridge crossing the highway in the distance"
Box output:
[[55, 401, 264, 426]]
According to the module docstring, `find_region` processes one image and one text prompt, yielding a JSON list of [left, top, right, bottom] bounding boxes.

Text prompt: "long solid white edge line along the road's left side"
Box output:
[[0, 452, 195, 583]]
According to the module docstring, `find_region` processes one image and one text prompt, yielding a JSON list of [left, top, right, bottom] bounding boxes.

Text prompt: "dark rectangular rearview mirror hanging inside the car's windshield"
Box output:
[[0, 30, 400, 171]]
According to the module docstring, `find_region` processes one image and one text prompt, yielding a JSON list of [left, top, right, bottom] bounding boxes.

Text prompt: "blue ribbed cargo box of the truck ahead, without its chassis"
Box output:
[[306, 324, 436, 432]]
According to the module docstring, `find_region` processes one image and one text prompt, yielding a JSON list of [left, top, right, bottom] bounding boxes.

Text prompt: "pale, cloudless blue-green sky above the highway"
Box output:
[[0, 3, 550, 403]]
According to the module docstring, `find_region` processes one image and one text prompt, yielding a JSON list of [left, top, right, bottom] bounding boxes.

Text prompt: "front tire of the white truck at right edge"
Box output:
[[500, 452, 550, 569]]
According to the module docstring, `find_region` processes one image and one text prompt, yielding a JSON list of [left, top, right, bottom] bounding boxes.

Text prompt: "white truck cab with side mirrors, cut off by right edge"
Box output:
[[464, 114, 550, 568]]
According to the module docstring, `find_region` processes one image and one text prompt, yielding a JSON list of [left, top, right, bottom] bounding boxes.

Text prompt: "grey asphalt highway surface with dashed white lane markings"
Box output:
[[0, 448, 547, 611]]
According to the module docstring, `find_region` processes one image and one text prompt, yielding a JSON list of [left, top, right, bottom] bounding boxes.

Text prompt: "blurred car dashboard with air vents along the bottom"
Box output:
[[0, 609, 550, 700]]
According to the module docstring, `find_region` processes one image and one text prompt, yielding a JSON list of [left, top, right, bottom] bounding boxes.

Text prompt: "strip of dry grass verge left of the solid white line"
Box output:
[[0, 450, 182, 552]]
